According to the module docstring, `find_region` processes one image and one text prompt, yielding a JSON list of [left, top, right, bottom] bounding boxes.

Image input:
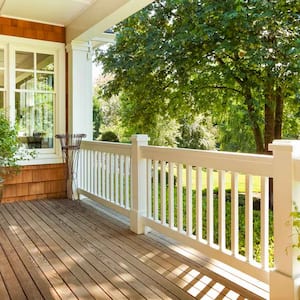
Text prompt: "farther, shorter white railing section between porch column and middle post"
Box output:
[[78, 142, 132, 216]]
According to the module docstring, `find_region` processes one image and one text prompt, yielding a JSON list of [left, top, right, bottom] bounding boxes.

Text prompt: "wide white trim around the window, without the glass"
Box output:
[[0, 35, 66, 165]]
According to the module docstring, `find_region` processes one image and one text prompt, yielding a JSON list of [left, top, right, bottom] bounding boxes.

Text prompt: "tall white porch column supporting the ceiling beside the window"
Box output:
[[67, 41, 93, 140]]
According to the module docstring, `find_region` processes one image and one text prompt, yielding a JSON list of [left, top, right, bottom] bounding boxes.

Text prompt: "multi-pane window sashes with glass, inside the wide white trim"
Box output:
[[15, 51, 55, 149]]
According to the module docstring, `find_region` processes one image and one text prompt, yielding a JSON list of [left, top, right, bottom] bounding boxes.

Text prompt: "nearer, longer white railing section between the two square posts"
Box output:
[[141, 146, 273, 282]]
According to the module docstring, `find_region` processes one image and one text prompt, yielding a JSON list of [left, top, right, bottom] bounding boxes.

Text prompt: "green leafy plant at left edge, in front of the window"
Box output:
[[0, 110, 35, 202]]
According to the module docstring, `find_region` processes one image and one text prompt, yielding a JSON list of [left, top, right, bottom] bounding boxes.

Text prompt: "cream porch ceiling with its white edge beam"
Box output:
[[0, 0, 153, 43]]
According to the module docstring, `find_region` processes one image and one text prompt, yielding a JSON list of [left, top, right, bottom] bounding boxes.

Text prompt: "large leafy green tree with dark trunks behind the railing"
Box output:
[[96, 0, 300, 153]]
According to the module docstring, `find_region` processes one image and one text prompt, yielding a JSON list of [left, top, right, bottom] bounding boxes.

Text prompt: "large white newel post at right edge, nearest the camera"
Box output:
[[269, 140, 300, 300]]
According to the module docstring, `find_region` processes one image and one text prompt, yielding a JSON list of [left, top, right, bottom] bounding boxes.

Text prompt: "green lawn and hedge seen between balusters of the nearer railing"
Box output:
[[152, 169, 273, 266]]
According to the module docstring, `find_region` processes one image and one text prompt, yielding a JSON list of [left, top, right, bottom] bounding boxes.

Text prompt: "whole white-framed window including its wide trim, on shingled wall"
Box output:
[[0, 36, 65, 163]]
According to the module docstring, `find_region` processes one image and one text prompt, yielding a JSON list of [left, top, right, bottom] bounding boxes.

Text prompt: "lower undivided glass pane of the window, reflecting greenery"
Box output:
[[15, 92, 54, 148]]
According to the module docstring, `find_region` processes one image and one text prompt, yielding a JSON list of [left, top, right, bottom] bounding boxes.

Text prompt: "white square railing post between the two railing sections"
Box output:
[[130, 134, 149, 234]]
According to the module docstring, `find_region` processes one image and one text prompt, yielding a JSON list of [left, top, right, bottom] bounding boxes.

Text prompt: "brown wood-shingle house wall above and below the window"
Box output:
[[0, 17, 67, 202]]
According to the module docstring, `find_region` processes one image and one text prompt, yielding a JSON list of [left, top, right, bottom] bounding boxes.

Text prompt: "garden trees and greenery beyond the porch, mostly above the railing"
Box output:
[[89, 0, 300, 268]]
